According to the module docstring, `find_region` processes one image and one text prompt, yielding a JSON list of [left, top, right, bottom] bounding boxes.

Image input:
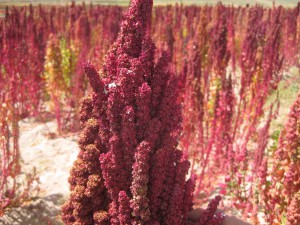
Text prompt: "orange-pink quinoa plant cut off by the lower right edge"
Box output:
[[261, 95, 300, 225]]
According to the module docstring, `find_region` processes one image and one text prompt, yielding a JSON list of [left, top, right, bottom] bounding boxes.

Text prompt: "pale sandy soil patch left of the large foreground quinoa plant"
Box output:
[[0, 119, 79, 225]]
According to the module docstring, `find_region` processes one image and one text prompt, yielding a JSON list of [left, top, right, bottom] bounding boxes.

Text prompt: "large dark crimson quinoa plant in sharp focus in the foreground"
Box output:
[[62, 0, 223, 225]]
